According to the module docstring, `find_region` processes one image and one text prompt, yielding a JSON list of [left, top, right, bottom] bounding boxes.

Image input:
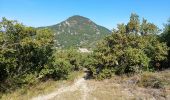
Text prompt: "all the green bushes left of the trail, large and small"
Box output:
[[0, 18, 87, 92]]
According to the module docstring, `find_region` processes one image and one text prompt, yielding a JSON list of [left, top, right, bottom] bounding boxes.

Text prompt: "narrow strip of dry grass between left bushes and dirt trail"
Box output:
[[1, 72, 83, 100]]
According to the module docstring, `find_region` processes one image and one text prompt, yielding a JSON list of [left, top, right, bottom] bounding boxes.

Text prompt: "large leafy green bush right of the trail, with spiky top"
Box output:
[[87, 14, 168, 79]]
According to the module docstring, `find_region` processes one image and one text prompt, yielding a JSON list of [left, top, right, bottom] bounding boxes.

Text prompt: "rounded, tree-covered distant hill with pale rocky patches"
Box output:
[[40, 15, 111, 48]]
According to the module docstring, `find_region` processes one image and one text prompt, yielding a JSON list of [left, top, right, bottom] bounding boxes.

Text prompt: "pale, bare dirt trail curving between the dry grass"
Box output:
[[32, 74, 89, 100]]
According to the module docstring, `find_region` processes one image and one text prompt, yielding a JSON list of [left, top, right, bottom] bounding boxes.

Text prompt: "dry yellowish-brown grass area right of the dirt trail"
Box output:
[[85, 70, 170, 100]]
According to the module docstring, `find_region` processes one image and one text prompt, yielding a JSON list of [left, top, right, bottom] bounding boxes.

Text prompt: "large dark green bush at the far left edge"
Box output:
[[0, 18, 53, 91]]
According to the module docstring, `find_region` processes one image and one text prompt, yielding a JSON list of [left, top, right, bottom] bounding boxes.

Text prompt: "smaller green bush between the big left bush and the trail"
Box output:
[[39, 49, 86, 79]]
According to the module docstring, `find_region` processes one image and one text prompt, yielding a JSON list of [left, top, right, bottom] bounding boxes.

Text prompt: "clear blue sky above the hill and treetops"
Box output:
[[0, 0, 170, 29]]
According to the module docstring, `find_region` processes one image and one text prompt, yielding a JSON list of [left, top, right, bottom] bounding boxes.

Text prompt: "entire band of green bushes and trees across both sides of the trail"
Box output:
[[0, 14, 170, 92]]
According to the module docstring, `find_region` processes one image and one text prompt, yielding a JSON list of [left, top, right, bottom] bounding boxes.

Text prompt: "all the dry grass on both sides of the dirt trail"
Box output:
[[2, 70, 170, 100]]
